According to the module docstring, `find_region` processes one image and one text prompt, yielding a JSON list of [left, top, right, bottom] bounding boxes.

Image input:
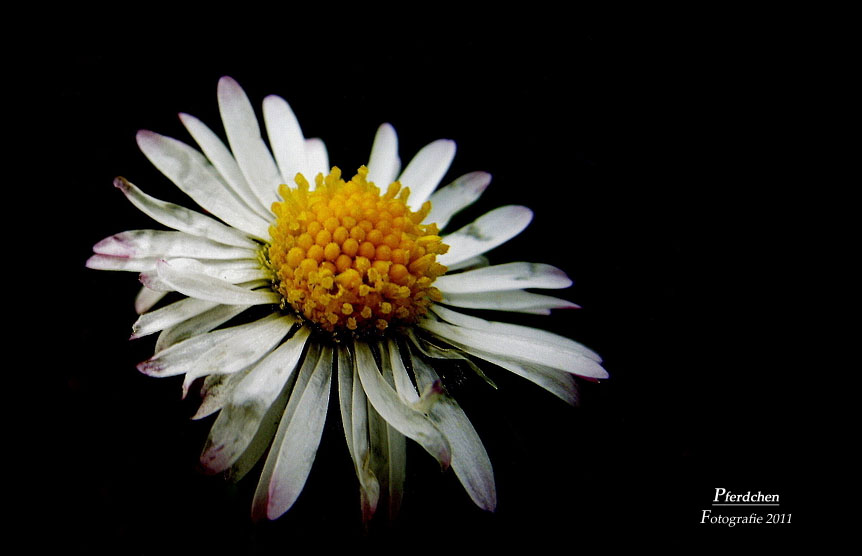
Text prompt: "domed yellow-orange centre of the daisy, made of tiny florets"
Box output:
[[268, 166, 449, 335]]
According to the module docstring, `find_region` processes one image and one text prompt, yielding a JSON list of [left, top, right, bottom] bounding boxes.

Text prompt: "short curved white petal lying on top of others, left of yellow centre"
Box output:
[[156, 261, 281, 305]]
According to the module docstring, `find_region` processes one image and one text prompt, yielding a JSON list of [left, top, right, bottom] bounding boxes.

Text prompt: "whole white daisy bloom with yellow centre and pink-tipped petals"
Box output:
[[87, 77, 607, 520]]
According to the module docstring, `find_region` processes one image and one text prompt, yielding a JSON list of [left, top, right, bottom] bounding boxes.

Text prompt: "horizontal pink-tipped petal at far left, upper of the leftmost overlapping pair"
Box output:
[[93, 230, 257, 259]]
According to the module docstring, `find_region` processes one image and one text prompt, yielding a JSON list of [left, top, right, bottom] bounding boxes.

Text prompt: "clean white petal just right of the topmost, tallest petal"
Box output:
[[263, 95, 310, 189]]
